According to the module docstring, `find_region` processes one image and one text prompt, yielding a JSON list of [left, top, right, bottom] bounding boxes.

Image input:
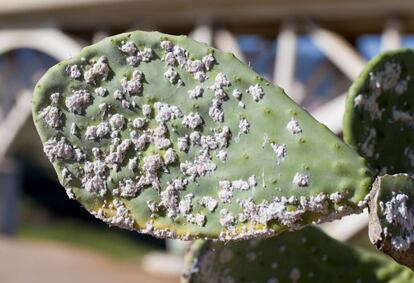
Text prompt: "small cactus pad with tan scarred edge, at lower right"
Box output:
[[369, 174, 414, 270]]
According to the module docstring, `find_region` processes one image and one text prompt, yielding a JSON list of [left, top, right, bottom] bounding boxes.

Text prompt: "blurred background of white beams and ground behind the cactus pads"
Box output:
[[0, 0, 414, 283]]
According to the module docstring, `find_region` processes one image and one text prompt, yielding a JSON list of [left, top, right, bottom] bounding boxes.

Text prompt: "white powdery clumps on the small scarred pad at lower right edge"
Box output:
[[380, 192, 414, 251]]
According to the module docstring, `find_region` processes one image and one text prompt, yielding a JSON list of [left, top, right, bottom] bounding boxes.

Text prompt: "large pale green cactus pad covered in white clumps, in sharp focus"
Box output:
[[33, 31, 372, 240]]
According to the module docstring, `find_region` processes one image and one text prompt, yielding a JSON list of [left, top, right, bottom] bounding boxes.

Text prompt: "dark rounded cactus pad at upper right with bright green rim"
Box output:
[[344, 49, 414, 175]]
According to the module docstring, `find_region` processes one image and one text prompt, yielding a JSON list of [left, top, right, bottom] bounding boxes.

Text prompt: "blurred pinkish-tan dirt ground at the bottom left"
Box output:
[[0, 238, 179, 283]]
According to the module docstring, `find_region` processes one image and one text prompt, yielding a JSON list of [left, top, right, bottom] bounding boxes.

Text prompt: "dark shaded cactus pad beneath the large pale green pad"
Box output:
[[181, 227, 414, 283]]
